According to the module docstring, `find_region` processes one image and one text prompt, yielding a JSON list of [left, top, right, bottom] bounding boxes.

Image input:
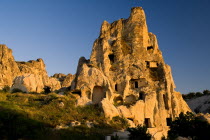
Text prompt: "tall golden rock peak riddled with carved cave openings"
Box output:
[[72, 7, 190, 139]]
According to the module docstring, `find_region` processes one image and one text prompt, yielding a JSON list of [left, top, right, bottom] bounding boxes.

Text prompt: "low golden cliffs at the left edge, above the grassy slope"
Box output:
[[0, 45, 61, 92]]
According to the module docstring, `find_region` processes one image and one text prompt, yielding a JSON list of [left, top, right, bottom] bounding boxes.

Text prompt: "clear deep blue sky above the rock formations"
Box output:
[[0, 0, 210, 93]]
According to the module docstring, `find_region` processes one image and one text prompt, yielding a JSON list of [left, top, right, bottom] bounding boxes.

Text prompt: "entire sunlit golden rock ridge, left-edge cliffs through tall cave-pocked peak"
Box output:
[[0, 7, 191, 140]]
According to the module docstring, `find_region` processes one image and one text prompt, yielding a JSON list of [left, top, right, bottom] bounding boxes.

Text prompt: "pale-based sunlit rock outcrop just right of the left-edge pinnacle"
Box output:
[[12, 59, 61, 93]]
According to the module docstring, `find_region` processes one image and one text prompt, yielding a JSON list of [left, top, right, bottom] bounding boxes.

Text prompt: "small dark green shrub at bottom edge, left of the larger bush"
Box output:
[[127, 125, 152, 140]]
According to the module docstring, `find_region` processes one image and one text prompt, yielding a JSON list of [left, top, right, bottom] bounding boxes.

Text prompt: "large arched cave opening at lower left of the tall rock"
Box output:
[[92, 86, 106, 104]]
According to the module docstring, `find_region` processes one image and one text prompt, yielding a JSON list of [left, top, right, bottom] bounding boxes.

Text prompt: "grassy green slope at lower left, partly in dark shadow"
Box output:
[[0, 92, 128, 140]]
